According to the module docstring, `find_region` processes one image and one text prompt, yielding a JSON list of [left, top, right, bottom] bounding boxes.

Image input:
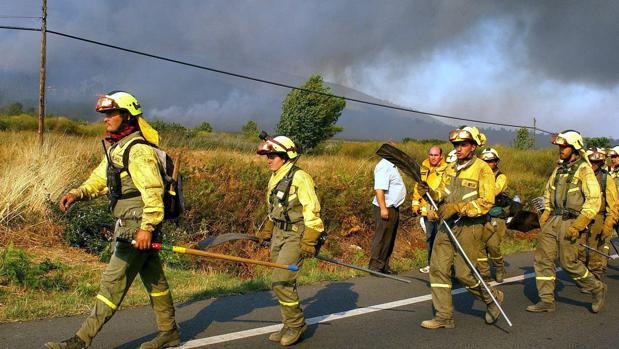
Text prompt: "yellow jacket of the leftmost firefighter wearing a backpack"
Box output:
[[69, 132, 164, 232]]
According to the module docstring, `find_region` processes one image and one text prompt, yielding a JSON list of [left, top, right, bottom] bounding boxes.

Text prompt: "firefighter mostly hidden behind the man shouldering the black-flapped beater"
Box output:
[[477, 147, 511, 283]]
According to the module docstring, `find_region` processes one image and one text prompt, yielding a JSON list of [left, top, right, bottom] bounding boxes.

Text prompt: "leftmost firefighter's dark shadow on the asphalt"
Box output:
[[116, 292, 280, 349]]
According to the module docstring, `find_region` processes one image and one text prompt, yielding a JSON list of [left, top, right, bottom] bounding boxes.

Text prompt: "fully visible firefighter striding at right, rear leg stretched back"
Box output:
[[527, 130, 607, 313]]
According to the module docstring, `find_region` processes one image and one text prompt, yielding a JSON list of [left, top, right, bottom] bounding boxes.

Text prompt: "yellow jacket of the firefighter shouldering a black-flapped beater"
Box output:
[[433, 157, 495, 217]]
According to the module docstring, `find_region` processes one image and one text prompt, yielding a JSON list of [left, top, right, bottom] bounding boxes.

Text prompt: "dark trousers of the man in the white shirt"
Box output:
[[370, 205, 400, 270]]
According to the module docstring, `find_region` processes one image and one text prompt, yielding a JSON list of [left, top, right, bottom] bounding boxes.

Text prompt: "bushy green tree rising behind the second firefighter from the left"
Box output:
[[277, 74, 346, 151]]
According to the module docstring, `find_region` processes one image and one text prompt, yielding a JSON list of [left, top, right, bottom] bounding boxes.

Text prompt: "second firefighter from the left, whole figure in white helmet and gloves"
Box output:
[[256, 136, 324, 346]]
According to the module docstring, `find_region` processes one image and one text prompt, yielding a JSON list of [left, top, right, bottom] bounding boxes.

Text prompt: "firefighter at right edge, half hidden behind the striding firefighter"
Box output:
[[579, 148, 619, 280]]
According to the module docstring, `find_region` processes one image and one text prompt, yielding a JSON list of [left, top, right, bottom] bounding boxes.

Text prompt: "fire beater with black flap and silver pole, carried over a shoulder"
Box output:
[[376, 143, 512, 326]]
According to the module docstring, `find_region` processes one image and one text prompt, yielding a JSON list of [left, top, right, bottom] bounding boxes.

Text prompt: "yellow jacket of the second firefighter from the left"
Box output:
[[267, 162, 325, 232]]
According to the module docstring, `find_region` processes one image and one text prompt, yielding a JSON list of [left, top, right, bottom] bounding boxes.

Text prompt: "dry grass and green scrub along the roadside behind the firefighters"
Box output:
[[0, 114, 556, 322]]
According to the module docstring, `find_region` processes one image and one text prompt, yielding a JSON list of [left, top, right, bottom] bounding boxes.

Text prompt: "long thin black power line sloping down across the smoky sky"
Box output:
[[0, 25, 555, 134]]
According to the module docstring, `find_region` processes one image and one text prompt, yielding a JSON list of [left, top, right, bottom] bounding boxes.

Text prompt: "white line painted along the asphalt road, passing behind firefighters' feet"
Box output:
[[178, 254, 619, 349]]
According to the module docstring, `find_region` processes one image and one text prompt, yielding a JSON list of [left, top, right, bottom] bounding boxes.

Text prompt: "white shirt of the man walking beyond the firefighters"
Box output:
[[372, 159, 406, 207]]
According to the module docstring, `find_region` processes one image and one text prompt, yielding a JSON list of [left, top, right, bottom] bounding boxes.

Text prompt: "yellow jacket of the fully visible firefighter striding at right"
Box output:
[[544, 160, 602, 219]]
